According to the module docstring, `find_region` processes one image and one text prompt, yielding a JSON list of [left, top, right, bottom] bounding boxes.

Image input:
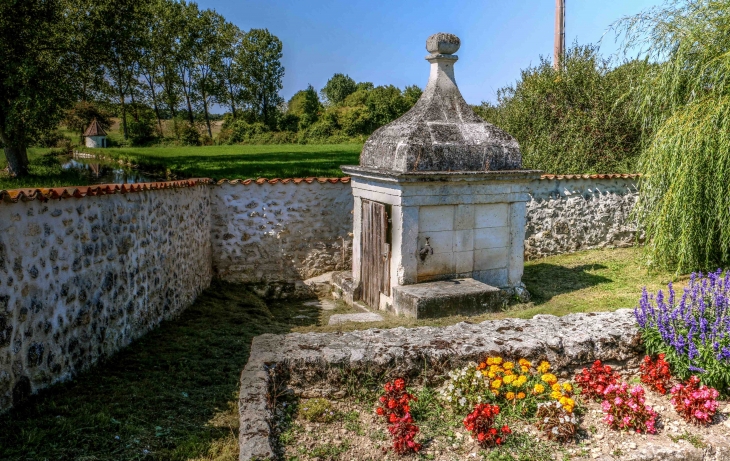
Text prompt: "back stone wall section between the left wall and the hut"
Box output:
[[211, 179, 353, 297]]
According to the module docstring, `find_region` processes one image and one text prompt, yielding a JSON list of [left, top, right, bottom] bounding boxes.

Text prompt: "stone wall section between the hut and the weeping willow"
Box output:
[[525, 175, 641, 259]]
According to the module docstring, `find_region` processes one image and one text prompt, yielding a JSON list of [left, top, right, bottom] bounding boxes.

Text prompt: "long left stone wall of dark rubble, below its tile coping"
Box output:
[[0, 185, 212, 411]]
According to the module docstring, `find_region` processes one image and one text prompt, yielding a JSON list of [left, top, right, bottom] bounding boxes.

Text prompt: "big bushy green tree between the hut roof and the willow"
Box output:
[[476, 45, 643, 174]]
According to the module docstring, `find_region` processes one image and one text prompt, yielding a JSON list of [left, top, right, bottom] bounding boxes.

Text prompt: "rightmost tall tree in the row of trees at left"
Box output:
[[238, 29, 284, 128]]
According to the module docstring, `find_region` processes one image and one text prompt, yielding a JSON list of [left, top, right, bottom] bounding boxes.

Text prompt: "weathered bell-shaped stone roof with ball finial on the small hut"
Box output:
[[360, 33, 522, 173]]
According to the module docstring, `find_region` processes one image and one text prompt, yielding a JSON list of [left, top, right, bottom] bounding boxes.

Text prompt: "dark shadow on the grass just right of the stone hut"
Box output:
[[522, 263, 613, 305]]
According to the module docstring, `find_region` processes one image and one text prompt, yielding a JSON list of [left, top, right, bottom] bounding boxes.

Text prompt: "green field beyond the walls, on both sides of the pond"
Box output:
[[0, 144, 362, 190]]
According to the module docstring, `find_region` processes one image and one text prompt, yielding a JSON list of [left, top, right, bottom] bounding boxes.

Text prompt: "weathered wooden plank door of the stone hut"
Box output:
[[360, 200, 390, 309]]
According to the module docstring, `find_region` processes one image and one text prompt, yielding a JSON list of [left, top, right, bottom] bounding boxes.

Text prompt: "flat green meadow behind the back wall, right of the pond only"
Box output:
[[99, 144, 362, 179]]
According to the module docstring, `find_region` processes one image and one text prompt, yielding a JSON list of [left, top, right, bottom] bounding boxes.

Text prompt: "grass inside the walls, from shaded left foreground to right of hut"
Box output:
[[0, 248, 671, 461]]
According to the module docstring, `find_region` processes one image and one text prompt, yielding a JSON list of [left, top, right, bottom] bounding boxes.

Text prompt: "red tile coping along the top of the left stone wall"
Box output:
[[0, 178, 211, 203]]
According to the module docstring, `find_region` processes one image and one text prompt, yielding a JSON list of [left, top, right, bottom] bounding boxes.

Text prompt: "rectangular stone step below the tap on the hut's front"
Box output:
[[393, 278, 503, 319]]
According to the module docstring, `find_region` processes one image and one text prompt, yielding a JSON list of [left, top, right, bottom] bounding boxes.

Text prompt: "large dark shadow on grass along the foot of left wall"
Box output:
[[0, 282, 318, 461]]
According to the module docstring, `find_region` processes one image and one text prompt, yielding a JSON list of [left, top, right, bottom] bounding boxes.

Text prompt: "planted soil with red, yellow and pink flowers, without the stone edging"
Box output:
[[274, 357, 730, 460]]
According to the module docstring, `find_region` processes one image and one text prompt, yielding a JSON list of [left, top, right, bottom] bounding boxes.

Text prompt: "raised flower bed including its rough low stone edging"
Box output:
[[241, 311, 730, 459]]
